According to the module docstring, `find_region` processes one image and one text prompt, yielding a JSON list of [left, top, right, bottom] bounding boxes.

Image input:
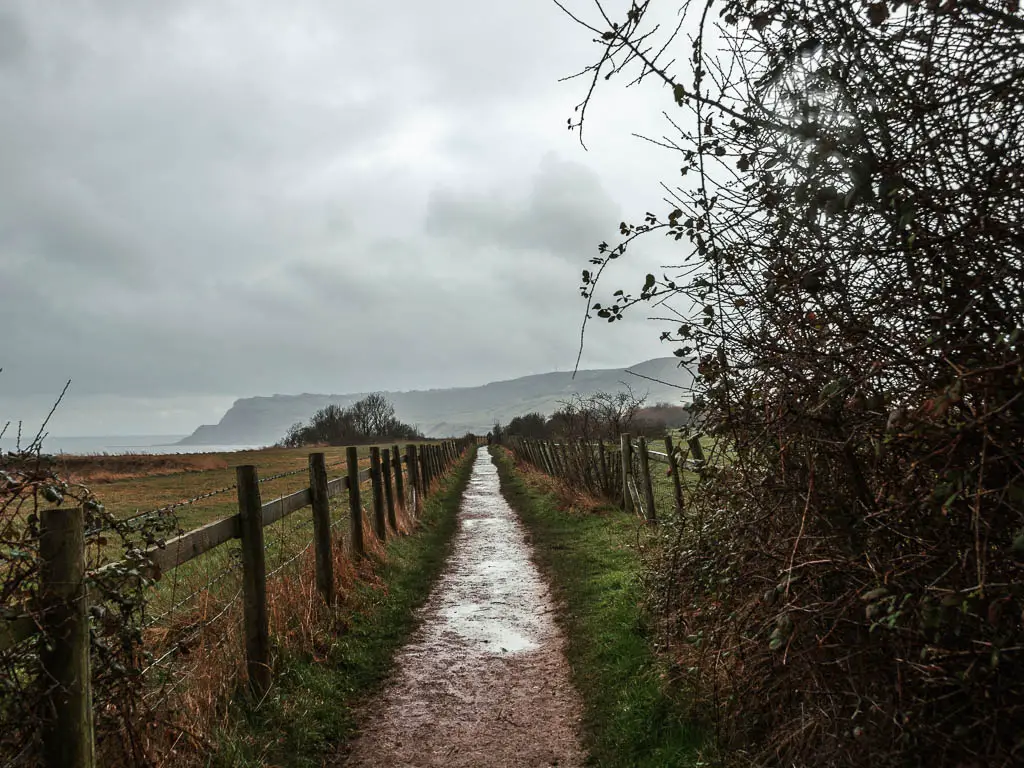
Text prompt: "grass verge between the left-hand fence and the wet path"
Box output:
[[209, 452, 472, 768]]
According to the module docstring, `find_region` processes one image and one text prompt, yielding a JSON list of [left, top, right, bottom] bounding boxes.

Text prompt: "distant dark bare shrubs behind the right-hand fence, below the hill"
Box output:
[[490, 388, 692, 442]]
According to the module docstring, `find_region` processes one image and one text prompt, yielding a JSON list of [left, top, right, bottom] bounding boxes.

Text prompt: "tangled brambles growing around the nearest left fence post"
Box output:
[[0, 438, 176, 765]]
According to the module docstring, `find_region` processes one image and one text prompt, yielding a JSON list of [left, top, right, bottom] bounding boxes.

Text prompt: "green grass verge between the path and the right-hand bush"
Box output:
[[496, 452, 700, 768]]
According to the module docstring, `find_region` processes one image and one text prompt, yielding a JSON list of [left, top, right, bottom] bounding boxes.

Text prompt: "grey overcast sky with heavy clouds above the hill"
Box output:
[[0, 0, 692, 435]]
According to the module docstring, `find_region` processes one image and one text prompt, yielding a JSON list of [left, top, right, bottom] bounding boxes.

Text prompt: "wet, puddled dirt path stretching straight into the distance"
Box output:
[[342, 450, 584, 768]]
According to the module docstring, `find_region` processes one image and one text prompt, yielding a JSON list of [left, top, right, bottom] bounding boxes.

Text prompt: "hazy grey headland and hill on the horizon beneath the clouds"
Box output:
[[178, 357, 692, 445]]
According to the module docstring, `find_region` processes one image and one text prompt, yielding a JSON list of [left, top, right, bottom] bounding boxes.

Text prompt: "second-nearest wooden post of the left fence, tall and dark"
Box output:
[[234, 464, 270, 696]]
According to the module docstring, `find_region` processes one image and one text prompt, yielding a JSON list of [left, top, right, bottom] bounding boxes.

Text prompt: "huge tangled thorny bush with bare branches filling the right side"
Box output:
[[570, 0, 1024, 766]]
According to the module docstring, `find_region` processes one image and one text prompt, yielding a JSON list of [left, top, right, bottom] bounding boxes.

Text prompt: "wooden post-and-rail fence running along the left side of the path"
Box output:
[[0, 437, 473, 768]]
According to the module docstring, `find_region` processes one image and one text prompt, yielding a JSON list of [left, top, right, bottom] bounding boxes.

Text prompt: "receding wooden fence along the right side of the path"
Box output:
[[505, 433, 707, 523]]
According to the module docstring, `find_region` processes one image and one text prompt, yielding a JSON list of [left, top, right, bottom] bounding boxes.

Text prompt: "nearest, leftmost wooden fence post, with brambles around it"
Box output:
[[39, 507, 95, 768]]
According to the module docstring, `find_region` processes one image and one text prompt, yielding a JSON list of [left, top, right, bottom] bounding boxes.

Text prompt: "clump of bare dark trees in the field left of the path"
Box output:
[[282, 393, 423, 447]]
